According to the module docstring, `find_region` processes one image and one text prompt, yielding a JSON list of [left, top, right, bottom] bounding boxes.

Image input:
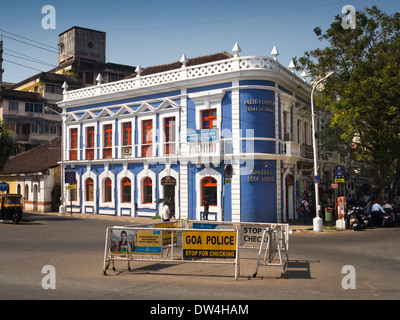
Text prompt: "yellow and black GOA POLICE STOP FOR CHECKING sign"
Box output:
[[183, 231, 237, 258]]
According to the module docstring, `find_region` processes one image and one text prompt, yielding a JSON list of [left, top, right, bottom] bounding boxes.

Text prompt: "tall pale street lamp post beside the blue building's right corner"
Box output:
[[311, 72, 335, 231]]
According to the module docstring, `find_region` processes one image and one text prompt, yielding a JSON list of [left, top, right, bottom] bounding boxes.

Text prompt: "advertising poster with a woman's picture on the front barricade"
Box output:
[[110, 229, 162, 256]]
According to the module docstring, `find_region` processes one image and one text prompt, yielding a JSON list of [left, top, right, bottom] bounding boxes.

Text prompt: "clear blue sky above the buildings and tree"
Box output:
[[0, 0, 400, 83]]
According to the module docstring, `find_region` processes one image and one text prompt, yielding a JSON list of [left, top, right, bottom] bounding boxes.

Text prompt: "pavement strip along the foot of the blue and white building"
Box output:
[[25, 211, 318, 232]]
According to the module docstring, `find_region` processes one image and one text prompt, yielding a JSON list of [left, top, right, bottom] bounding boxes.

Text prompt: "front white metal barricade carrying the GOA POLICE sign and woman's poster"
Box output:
[[103, 225, 240, 280]]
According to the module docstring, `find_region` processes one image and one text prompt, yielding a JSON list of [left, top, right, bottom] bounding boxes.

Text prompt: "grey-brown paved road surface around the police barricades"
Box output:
[[0, 214, 400, 300]]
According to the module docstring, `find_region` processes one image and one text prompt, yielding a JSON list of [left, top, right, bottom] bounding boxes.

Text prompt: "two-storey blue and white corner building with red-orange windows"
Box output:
[[58, 45, 340, 222]]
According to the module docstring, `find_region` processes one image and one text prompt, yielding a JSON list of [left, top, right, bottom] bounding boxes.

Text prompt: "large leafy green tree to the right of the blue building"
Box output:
[[294, 6, 400, 200]]
